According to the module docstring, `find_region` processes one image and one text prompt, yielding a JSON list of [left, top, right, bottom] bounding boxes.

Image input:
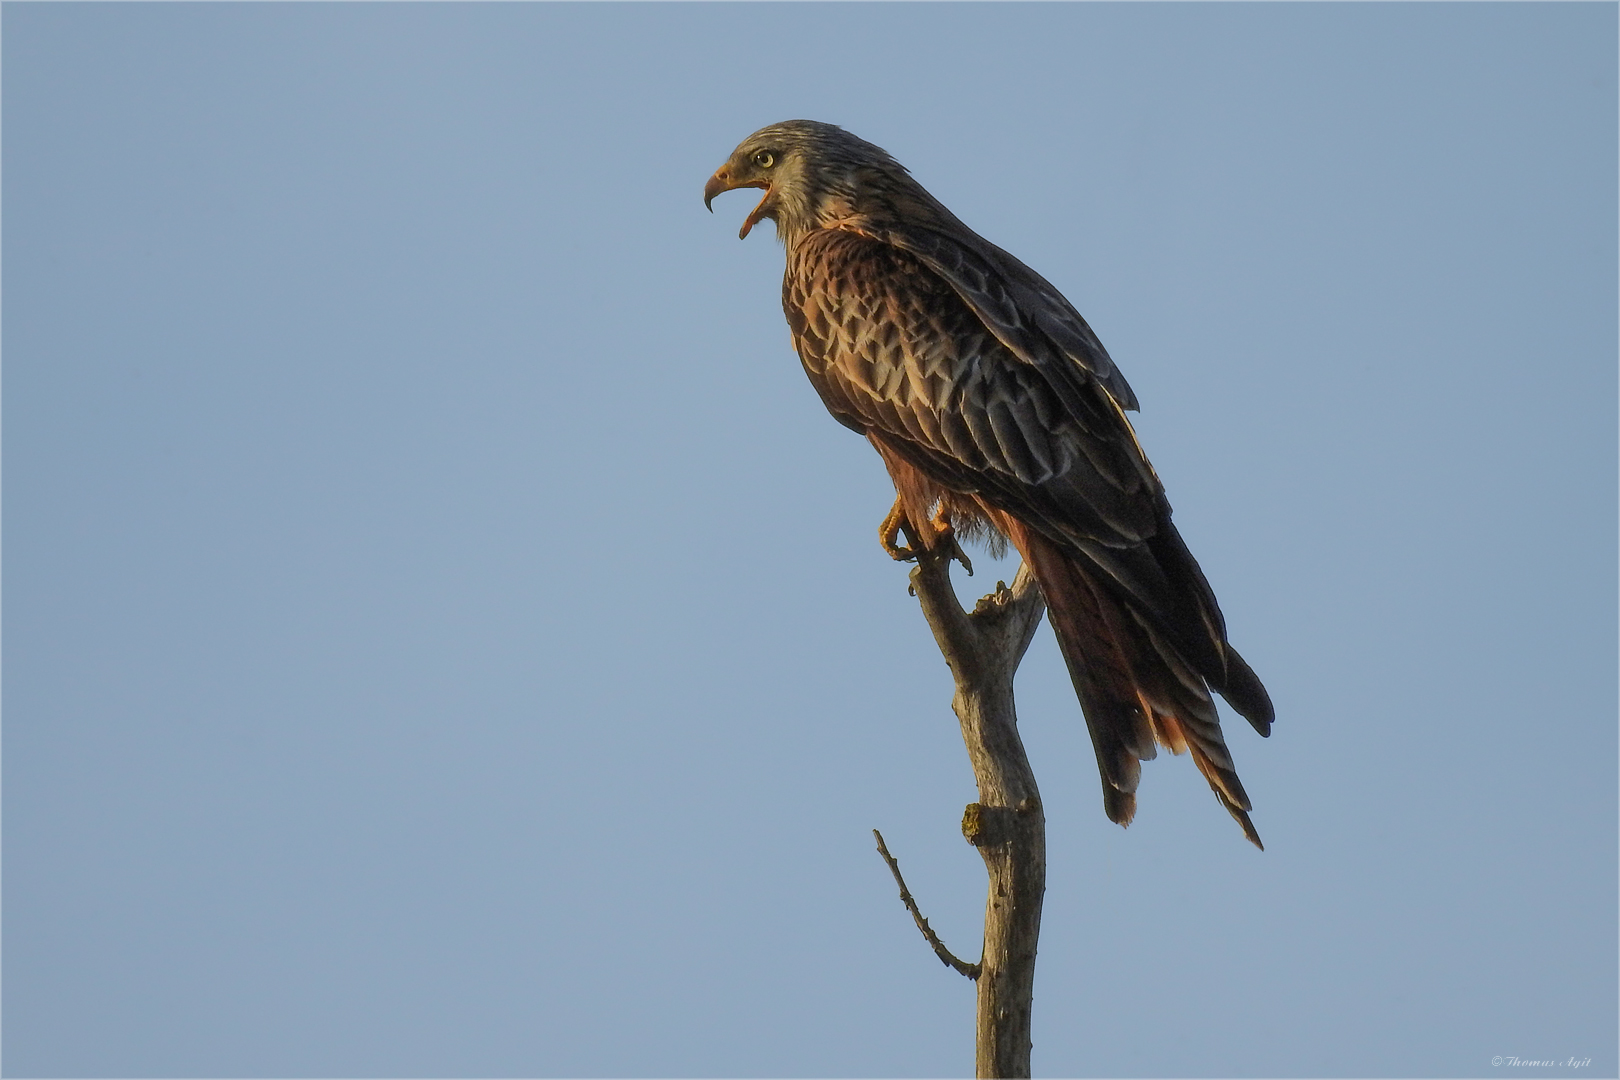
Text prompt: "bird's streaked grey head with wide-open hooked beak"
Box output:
[[703, 120, 920, 243]]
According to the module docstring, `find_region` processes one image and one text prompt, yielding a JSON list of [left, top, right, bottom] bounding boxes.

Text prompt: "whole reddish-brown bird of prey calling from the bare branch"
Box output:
[[703, 120, 1275, 850]]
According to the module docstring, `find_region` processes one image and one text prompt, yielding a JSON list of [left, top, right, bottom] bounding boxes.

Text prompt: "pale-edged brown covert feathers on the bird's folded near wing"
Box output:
[[782, 230, 1162, 547]]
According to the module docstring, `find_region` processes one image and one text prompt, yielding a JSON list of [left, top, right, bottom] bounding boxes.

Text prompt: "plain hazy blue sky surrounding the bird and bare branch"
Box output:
[[3, 3, 1620, 1077]]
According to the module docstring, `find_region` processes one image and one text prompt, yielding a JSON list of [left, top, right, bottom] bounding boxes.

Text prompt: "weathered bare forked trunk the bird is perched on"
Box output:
[[907, 552, 1047, 1077]]
